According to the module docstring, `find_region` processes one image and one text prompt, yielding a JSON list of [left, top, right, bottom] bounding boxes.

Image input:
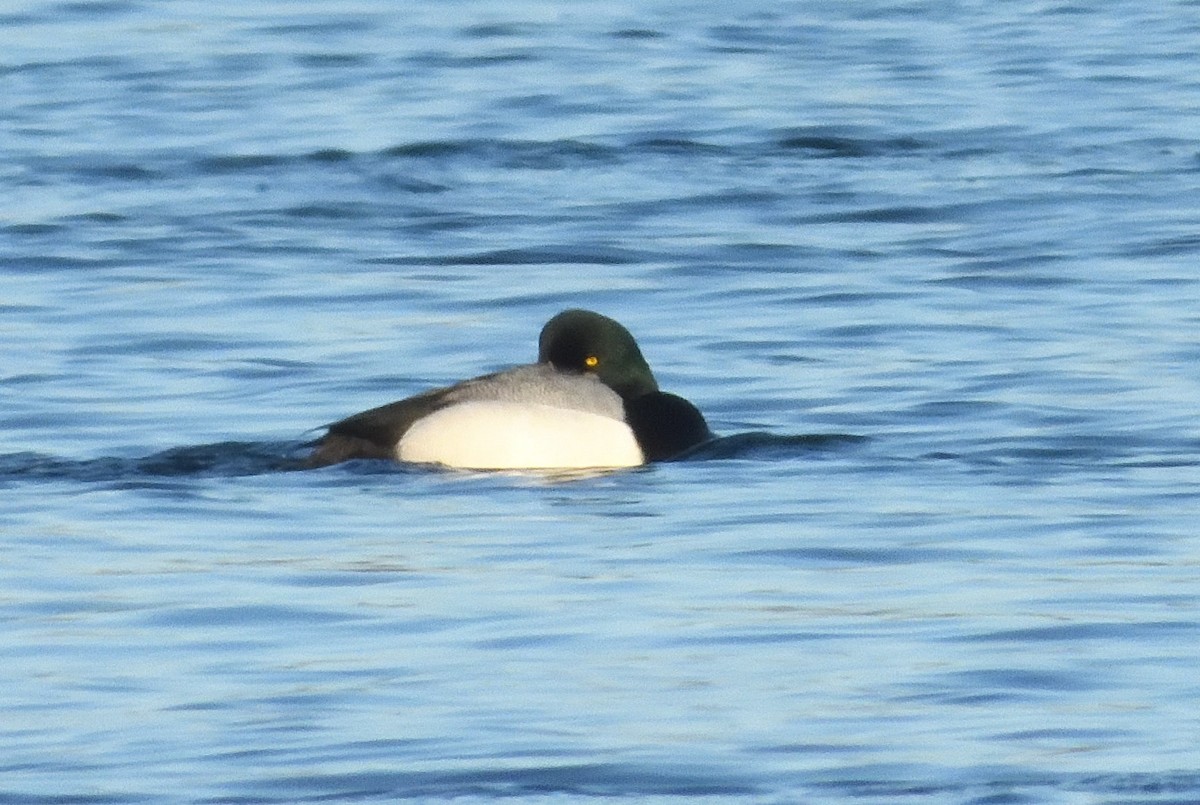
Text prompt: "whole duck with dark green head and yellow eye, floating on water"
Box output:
[[306, 308, 714, 470]]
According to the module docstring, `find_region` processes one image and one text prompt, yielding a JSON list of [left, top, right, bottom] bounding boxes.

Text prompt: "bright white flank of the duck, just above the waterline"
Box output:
[[396, 401, 646, 469]]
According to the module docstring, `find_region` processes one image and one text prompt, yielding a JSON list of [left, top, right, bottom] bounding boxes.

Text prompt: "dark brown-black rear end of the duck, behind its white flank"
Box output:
[[305, 389, 448, 467]]
